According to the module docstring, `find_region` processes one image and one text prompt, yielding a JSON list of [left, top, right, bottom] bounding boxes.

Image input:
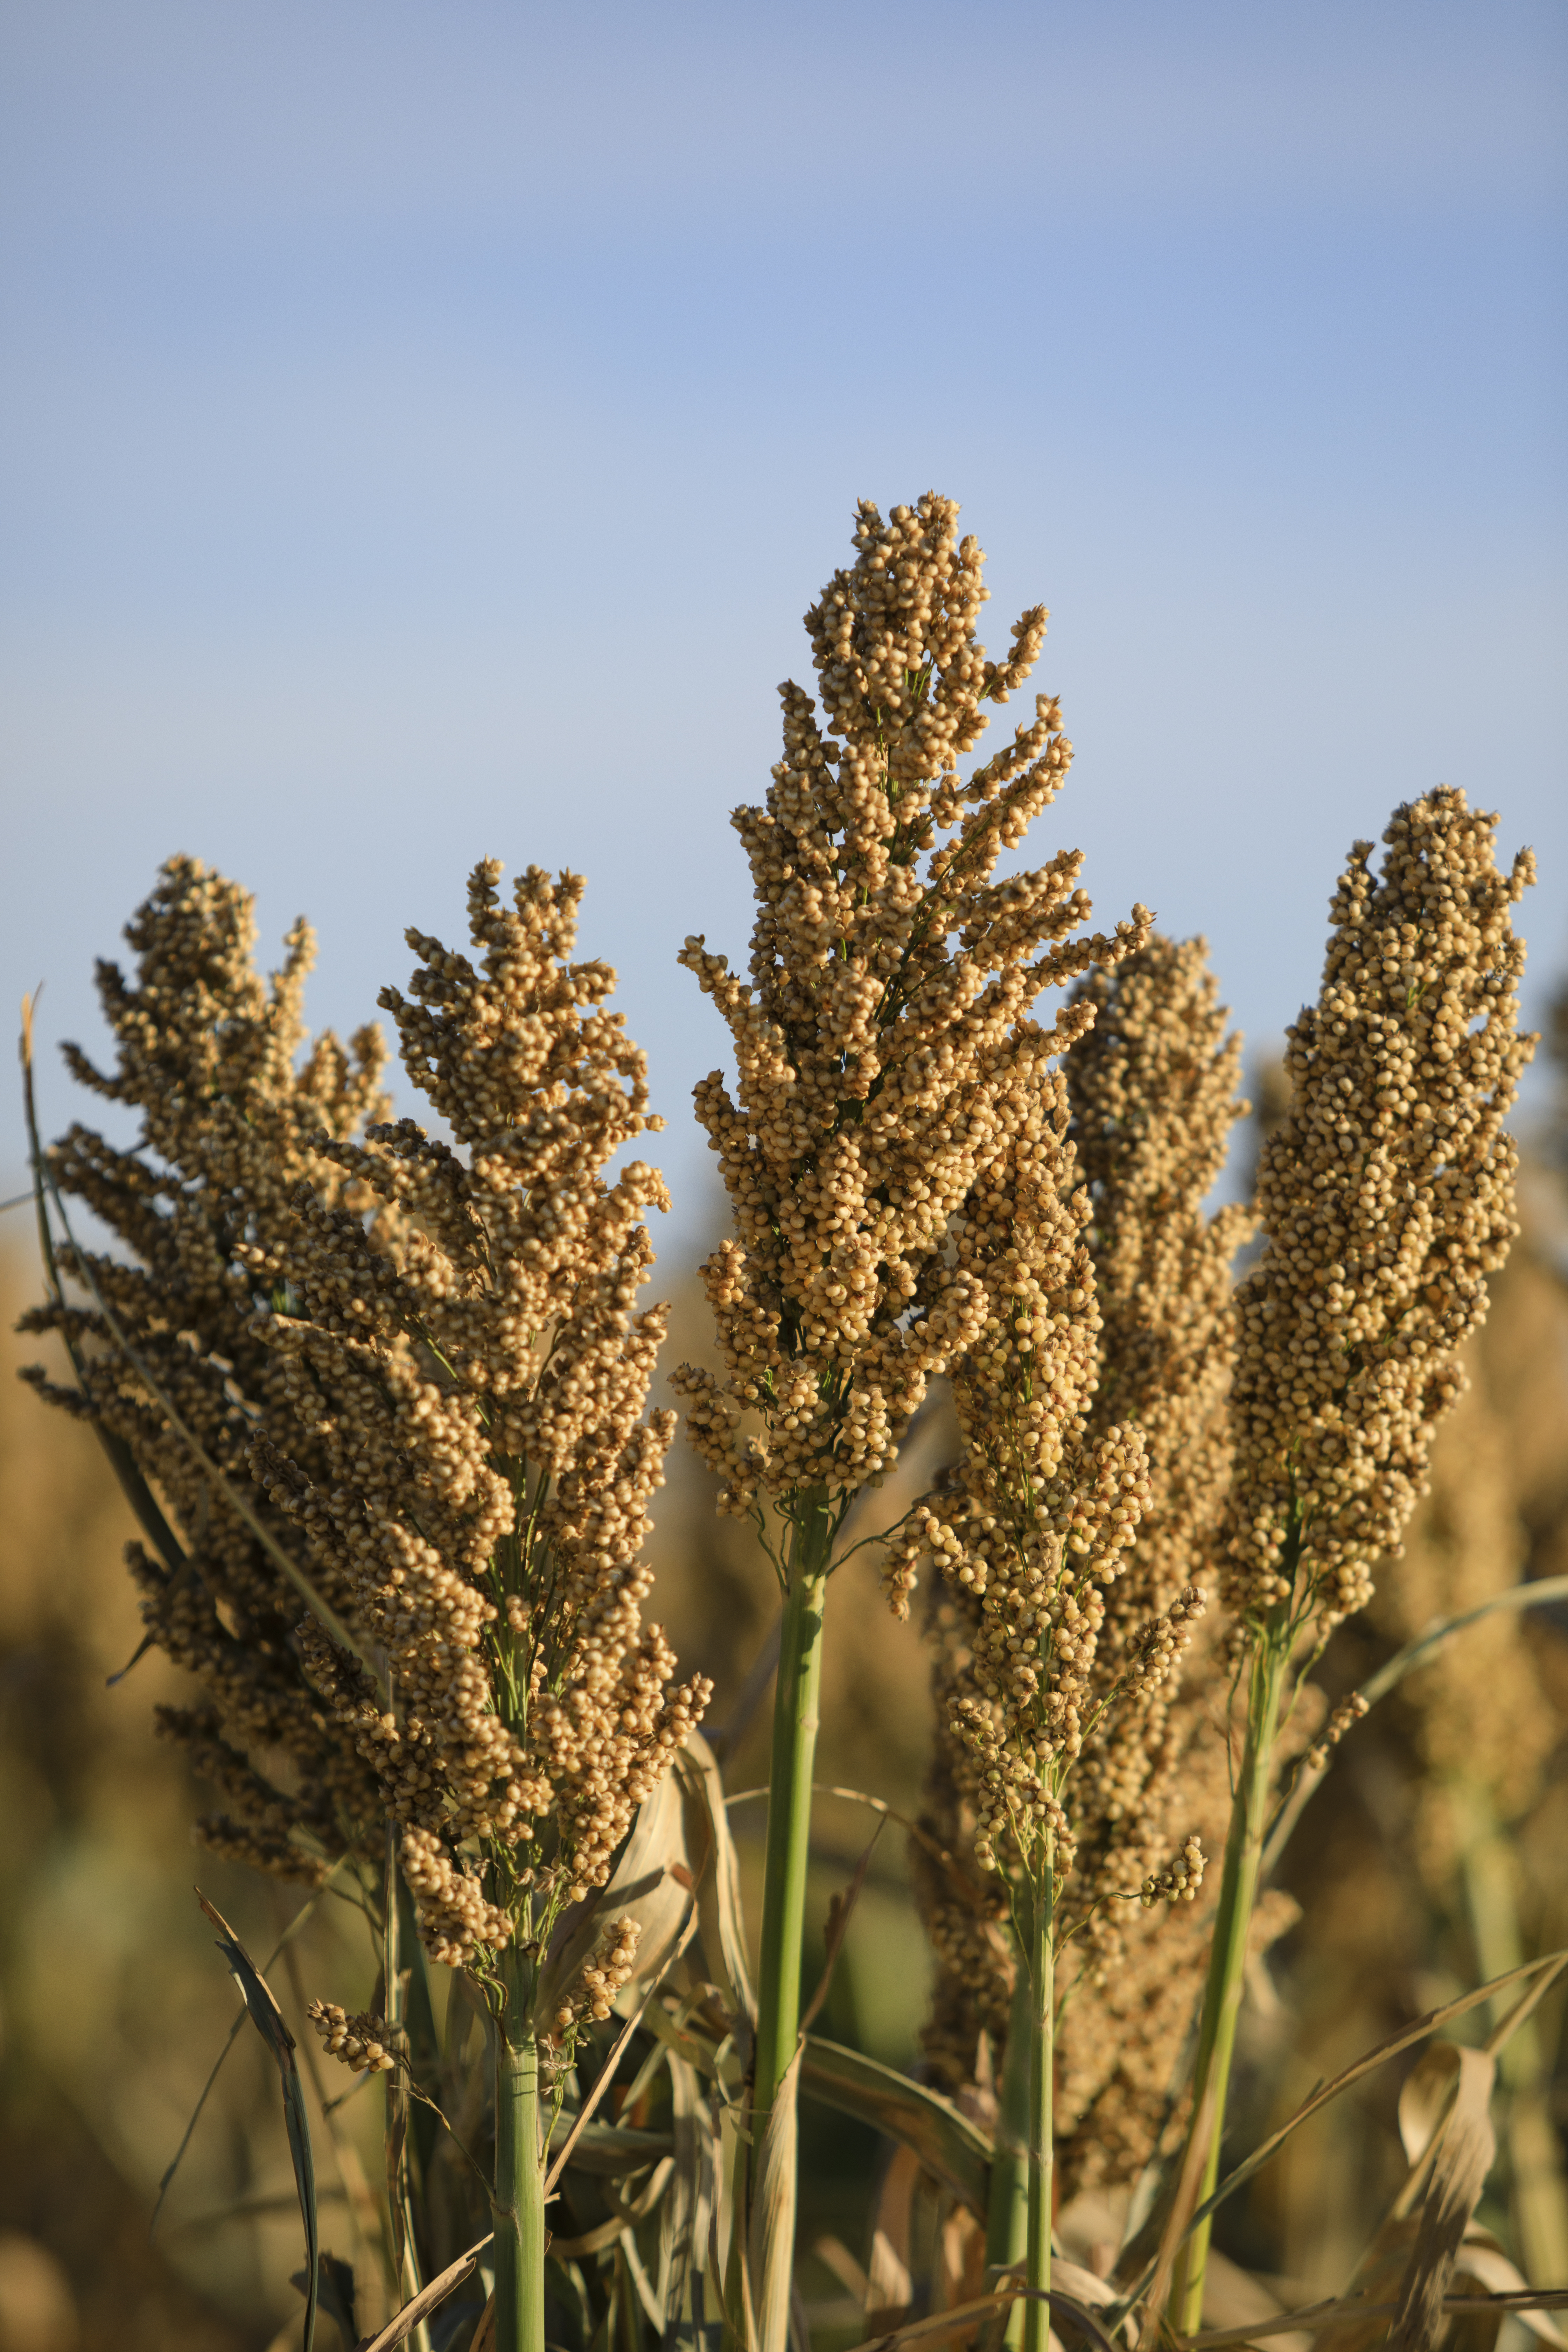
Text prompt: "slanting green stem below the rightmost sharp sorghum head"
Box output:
[[1171, 1604, 1293, 2336]]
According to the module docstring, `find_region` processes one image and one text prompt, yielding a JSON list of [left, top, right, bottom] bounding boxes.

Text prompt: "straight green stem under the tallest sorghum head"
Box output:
[[752, 1486, 832, 2324]]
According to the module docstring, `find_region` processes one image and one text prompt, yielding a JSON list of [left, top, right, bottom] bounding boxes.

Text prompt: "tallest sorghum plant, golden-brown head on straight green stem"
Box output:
[[677, 494, 1147, 2340]]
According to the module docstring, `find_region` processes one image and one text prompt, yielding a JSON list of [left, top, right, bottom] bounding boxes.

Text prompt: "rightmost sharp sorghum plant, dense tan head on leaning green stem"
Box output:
[[1178, 785, 1535, 2329]]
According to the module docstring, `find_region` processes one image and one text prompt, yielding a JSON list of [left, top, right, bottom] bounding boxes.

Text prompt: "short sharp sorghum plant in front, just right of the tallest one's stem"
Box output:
[[889, 992, 1213, 2343]]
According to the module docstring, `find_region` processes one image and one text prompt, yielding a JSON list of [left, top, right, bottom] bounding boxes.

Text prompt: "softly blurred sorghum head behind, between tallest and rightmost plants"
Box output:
[[908, 936, 1246, 2295]]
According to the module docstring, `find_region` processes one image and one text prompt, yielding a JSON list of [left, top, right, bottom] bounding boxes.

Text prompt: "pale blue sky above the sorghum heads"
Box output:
[[0, 0, 1568, 1251]]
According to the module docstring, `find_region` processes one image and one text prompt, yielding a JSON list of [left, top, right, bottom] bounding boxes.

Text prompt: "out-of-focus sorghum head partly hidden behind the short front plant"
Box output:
[[917, 936, 1248, 2201]]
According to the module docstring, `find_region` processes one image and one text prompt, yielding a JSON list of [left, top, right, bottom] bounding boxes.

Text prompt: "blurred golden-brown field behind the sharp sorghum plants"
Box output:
[[0, 1040, 1568, 2352]]
